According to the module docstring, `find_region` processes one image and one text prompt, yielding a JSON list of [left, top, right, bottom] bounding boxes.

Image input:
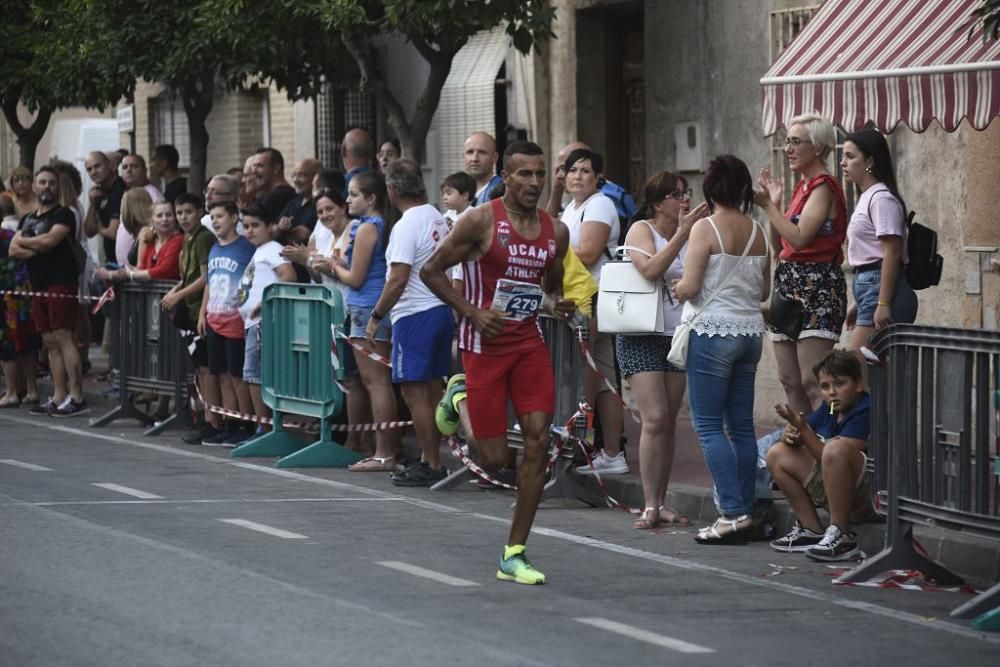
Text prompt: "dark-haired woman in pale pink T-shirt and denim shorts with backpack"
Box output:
[[840, 130, 917, 350]]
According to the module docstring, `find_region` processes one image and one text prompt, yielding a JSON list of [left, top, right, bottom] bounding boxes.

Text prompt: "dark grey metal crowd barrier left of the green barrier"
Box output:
[[91, 281, 193, 435]]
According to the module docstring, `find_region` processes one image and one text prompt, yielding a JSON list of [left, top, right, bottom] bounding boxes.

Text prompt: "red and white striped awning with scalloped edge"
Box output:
[[760, 0, 1000, 135]]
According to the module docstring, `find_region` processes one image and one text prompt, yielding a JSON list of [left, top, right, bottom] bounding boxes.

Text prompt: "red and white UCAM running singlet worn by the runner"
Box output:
[[458, 198, 556, 354]]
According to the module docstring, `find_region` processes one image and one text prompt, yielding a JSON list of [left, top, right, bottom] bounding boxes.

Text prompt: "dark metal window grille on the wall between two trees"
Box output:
[[316, 83, 376, 169]]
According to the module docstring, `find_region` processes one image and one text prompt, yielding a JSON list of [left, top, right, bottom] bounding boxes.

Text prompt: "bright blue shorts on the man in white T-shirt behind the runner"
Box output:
[[392, 306, 455, 382]]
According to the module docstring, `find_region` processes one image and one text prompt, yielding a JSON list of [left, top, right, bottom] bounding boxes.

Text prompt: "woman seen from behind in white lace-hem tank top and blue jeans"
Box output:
[[674, 155, 771, 544]]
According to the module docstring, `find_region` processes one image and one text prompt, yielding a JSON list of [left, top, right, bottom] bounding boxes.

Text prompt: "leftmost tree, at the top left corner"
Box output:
[[0, 0, 134, 169]]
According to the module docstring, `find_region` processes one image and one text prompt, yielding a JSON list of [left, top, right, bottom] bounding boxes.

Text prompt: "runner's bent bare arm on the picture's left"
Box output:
[[420, 206, 503, 337]]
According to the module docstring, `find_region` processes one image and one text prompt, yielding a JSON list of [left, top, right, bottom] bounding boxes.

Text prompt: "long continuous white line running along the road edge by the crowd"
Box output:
[[7, 414, 1000, 645]]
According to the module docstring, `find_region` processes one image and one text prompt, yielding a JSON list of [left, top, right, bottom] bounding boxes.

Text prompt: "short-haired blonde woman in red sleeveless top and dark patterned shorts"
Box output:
[[757, 113, 847, 414]]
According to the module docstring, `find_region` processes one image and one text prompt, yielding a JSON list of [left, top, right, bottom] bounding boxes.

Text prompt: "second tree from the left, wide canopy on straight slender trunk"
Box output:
[[89, 0, 353, 191]]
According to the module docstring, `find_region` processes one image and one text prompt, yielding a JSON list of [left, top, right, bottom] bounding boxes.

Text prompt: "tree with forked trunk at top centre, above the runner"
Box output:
[[300, 0, 555, 161]]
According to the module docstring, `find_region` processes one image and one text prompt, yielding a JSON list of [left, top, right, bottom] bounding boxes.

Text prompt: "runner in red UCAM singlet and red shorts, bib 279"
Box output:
[[420, 141, 575, 584]]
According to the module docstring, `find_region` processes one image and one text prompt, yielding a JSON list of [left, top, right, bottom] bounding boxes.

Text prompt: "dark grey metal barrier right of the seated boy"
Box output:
[[838, 324, 1000, 618]]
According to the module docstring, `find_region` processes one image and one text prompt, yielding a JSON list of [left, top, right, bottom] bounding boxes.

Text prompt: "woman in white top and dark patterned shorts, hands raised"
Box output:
[[616, 171, 708, 530]]
